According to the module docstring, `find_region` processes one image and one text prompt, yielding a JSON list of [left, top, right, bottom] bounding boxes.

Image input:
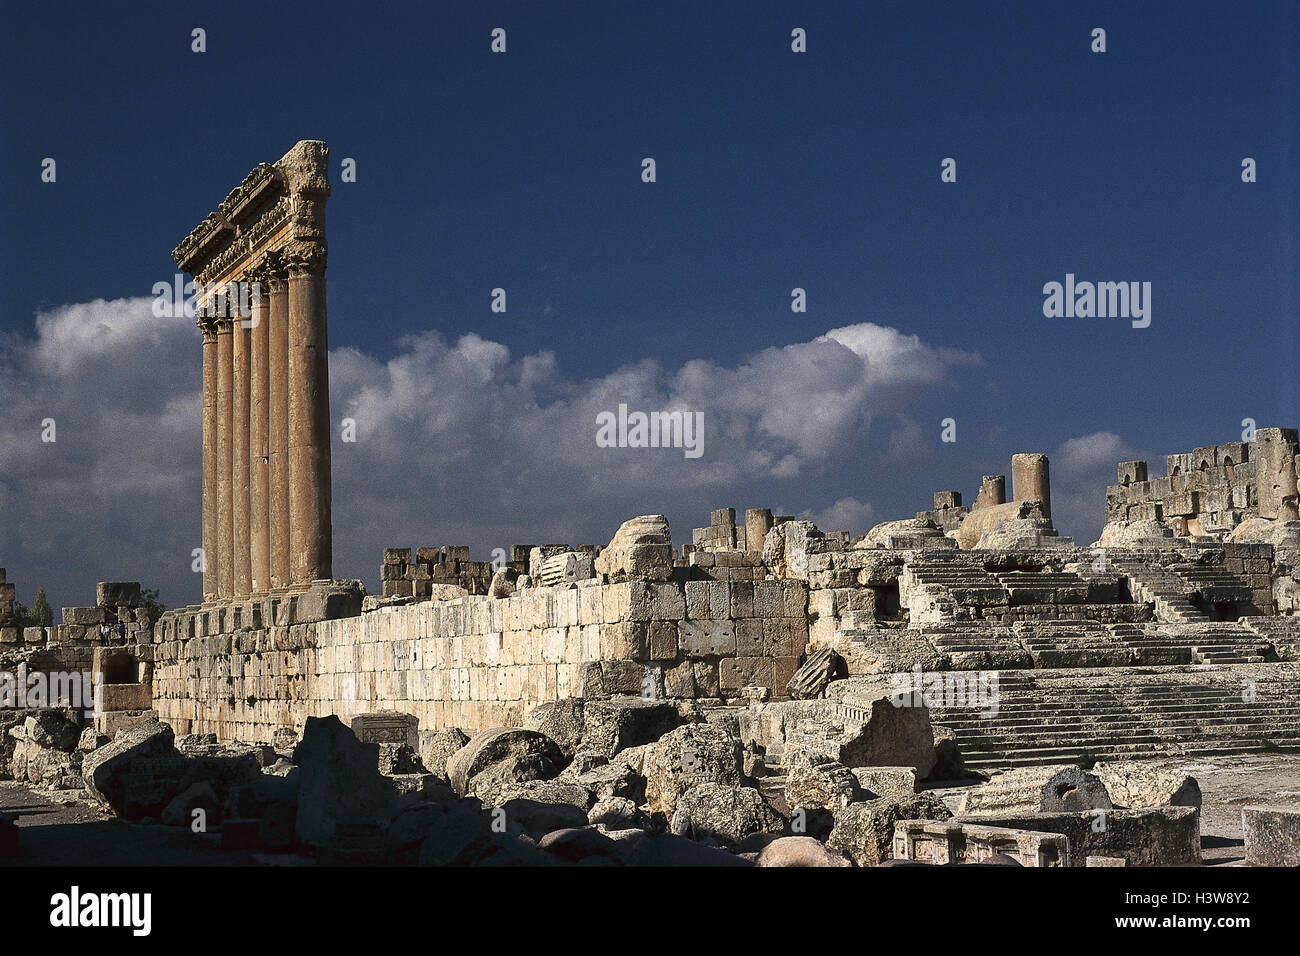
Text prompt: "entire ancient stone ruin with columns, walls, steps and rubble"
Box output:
[[0, 142, 1300, 868]]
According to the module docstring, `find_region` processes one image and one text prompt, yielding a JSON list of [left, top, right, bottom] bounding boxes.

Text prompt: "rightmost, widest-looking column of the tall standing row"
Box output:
[[283, 241, 333, 585]]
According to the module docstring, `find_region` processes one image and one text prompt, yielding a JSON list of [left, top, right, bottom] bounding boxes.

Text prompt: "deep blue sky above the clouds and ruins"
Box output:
[[0, 0, 1300, 608]]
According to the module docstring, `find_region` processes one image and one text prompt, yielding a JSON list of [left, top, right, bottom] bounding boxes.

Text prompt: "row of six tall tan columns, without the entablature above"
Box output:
[[200, 255, 332, 601]]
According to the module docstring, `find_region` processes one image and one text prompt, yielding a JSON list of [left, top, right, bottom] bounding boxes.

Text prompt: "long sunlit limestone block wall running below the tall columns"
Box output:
[[152, 581, 807, 741]]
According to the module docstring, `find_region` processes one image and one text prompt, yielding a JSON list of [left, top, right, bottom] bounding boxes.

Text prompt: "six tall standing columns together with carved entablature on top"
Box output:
[[173, 140, 333, 602]]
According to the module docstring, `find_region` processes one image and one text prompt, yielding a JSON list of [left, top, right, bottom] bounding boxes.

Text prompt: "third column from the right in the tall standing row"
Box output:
[[248, 273, 270, 594]]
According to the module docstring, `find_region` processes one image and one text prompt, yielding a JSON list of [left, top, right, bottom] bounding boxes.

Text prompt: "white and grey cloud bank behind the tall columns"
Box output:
[[0, 298, 979, 605]]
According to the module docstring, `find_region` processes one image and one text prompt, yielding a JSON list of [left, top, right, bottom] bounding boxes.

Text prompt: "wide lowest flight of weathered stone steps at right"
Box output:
[[931, 665, 1300, 769]]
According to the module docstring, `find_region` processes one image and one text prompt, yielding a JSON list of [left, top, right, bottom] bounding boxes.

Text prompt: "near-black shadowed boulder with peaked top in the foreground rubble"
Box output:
[[294, 715, 397, 847]]
